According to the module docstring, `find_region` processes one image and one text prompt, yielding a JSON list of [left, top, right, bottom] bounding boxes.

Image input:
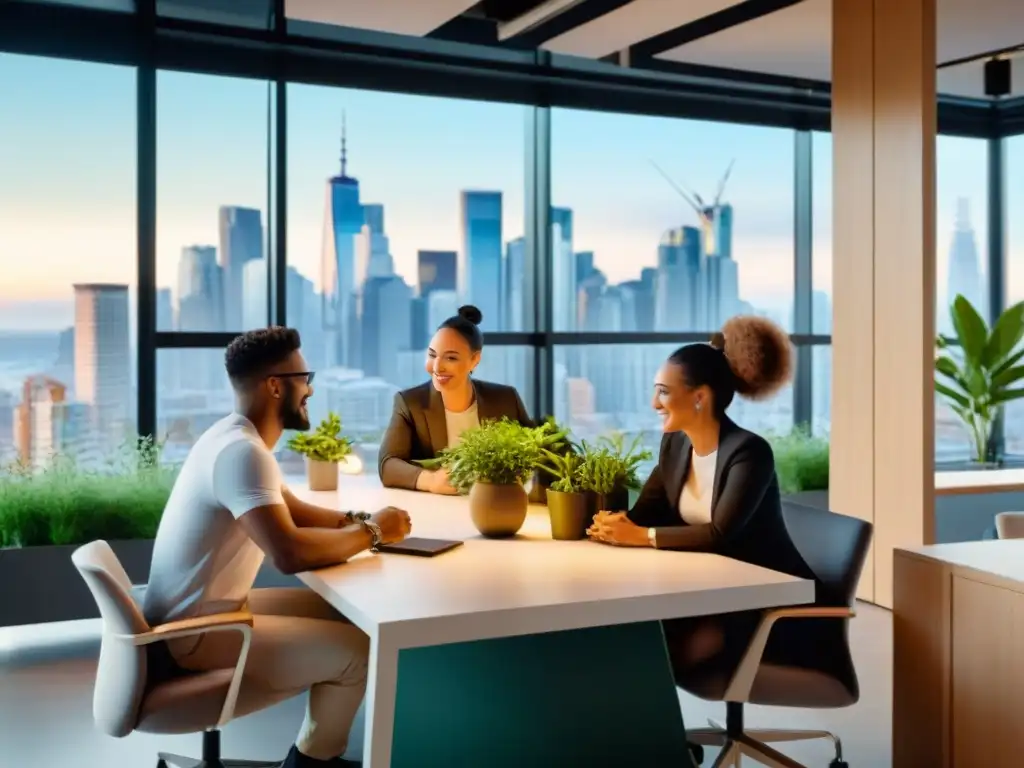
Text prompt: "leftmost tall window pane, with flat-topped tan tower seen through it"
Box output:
[[0, 53, 136, 467]]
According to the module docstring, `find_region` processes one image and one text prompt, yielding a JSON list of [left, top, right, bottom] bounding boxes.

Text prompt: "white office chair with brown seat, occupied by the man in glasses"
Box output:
[[72, 541, 281, 768]]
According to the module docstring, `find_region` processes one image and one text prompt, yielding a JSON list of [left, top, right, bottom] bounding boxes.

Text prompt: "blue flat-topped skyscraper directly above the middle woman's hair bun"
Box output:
[[456, 190, 502, 331]]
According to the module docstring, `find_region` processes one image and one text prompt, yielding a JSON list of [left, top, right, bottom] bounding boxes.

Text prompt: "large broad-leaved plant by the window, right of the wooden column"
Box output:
[[935, 295, 1024, 467]]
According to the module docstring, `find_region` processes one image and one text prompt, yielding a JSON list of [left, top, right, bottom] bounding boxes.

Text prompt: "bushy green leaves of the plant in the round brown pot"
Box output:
[[439, 418, 543, 493]]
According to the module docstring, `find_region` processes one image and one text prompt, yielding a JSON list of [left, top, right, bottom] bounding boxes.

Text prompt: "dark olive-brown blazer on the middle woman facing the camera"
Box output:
[[377, 381, 534, 490]]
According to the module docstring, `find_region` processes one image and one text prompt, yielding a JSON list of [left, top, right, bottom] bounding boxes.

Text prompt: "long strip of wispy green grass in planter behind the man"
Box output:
[[0, 437, 177, 547]]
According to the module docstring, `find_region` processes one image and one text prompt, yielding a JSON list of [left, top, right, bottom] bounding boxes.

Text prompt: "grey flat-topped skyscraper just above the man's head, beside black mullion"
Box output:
[[217, 206, 266, 331]]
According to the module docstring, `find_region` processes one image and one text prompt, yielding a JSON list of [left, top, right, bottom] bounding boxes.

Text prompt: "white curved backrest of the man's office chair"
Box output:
[[71, 541, 150, 737]]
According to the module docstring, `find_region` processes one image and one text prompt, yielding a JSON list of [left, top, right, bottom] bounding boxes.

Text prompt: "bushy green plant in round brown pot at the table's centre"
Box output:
[[440, 418, 542, 538]]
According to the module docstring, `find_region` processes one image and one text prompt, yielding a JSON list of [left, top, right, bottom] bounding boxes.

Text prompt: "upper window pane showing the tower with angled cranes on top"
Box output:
[[551, 110, 794, 332]]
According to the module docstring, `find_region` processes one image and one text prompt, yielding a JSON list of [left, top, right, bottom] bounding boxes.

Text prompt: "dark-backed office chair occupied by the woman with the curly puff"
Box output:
[[675, 502, 872, 768]]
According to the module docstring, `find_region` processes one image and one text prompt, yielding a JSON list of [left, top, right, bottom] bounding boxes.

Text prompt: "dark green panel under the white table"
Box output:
[[391, 622, 693, 768]]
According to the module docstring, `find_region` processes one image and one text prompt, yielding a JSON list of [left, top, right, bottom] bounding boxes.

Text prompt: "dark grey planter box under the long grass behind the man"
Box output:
[[0, 540, 300, 627]]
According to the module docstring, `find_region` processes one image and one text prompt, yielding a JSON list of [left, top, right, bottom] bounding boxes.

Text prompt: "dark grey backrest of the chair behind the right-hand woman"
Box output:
[[782, 501, 873, 607]]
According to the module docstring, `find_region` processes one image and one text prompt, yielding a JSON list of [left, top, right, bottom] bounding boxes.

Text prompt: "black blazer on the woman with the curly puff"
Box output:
[[629, 418, 807, 575]]
